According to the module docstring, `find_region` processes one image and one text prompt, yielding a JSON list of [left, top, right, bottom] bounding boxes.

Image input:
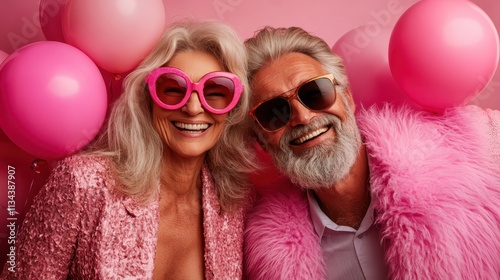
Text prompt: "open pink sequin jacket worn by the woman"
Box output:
[[0, 156, 243, 280]]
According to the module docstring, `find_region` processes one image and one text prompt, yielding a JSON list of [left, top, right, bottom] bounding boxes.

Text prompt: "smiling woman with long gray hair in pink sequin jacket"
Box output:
[[2, 22, 253, 279]]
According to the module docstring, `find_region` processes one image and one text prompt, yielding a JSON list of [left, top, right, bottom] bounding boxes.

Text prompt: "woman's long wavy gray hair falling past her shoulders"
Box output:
[[88, 20, 254, 208]]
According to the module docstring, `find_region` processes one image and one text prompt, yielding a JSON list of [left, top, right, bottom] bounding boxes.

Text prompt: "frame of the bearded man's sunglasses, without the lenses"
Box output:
[[248, 73, 339, 132]]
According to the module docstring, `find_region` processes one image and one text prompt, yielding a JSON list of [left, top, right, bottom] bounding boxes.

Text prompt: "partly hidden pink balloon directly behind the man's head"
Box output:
[[332, 24, 405, 108]]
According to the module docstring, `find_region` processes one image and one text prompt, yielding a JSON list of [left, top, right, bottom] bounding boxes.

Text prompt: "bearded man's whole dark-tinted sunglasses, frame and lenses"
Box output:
[[249, 74, 337, 132]]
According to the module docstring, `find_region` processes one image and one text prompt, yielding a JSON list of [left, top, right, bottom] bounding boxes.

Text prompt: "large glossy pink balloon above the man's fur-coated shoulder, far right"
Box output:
[[389, 0, 499, 112]]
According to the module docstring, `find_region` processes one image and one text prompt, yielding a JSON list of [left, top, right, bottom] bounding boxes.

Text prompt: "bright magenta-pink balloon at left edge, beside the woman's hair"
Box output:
[[0, 41, 107, 159]]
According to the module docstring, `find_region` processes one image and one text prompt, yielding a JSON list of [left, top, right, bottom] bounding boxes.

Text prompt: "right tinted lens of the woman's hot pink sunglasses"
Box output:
[[203, 77, 235, 109]]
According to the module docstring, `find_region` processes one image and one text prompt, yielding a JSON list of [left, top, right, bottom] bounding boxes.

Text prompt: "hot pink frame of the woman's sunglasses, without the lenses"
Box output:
[[146, 67, 244, 115]]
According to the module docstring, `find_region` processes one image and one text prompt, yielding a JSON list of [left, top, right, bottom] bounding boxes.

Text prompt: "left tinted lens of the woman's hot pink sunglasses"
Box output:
[[156, 73, 187, 105]]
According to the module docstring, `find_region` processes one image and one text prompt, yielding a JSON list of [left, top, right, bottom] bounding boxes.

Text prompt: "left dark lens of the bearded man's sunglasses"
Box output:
[[254, 97, 290, 131]]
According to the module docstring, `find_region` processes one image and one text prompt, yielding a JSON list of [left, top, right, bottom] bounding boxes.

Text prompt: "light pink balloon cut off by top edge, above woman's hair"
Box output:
[[61, 0, 165, 74]]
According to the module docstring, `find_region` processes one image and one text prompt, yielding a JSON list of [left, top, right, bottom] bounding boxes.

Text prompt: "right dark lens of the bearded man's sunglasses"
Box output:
[[297, 78, 336, 110]]
